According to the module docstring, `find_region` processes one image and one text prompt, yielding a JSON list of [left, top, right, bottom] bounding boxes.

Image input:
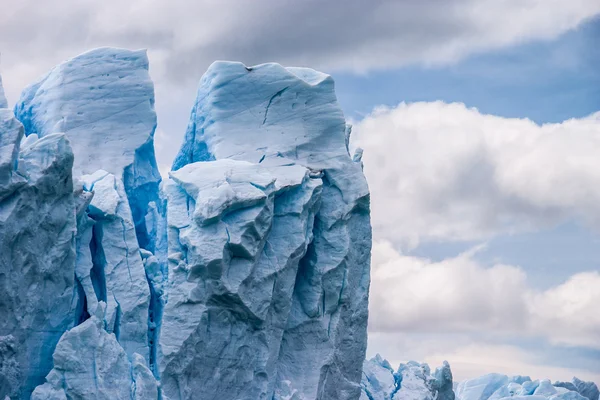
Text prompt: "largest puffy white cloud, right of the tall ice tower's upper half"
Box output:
[[352, 102, 600, 249]]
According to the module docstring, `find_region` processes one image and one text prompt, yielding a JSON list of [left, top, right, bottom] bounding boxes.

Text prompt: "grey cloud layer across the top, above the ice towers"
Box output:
[[0, 0, 600, 101]]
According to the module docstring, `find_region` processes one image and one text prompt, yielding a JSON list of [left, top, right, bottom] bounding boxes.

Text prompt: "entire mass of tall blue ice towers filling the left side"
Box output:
[[0, 48, 371, 400]]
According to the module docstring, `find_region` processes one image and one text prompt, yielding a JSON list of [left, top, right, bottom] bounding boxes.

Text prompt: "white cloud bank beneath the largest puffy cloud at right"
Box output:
[[369, 241, 600, 349]]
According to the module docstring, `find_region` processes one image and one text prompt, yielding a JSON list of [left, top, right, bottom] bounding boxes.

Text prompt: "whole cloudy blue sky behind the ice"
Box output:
[[0, 0, 600, 382]]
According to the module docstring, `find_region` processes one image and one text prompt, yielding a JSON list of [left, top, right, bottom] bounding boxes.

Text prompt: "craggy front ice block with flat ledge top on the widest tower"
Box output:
[[160, 159, 322, 400]]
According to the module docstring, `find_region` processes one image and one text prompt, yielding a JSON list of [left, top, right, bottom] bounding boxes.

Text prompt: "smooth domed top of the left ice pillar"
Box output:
[[15, 48, 159, 184]]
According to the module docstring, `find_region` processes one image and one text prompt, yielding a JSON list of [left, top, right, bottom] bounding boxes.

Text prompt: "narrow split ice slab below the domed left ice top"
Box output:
[[77, 171, 150, 359]]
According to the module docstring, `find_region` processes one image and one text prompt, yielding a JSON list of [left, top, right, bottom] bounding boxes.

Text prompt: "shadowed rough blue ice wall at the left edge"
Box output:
[[0, 85, 76, 399]]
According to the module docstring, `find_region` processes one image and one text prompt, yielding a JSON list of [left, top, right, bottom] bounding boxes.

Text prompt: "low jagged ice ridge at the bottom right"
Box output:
[[360, 354, 599, 400]]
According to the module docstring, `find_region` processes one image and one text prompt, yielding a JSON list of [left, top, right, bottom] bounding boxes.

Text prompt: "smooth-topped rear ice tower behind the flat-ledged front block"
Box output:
[[169, 62, 371, 400]]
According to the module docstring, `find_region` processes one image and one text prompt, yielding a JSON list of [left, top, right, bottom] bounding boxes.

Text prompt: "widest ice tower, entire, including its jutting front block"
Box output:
[[160, 62, 371, 399]]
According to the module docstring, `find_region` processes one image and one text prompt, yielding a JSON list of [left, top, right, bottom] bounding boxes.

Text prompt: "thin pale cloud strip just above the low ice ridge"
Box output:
[[367, 332, 600, 382]]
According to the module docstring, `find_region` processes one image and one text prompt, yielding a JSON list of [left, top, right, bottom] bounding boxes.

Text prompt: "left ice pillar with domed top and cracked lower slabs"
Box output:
[[15, 48, 160, 368]]
